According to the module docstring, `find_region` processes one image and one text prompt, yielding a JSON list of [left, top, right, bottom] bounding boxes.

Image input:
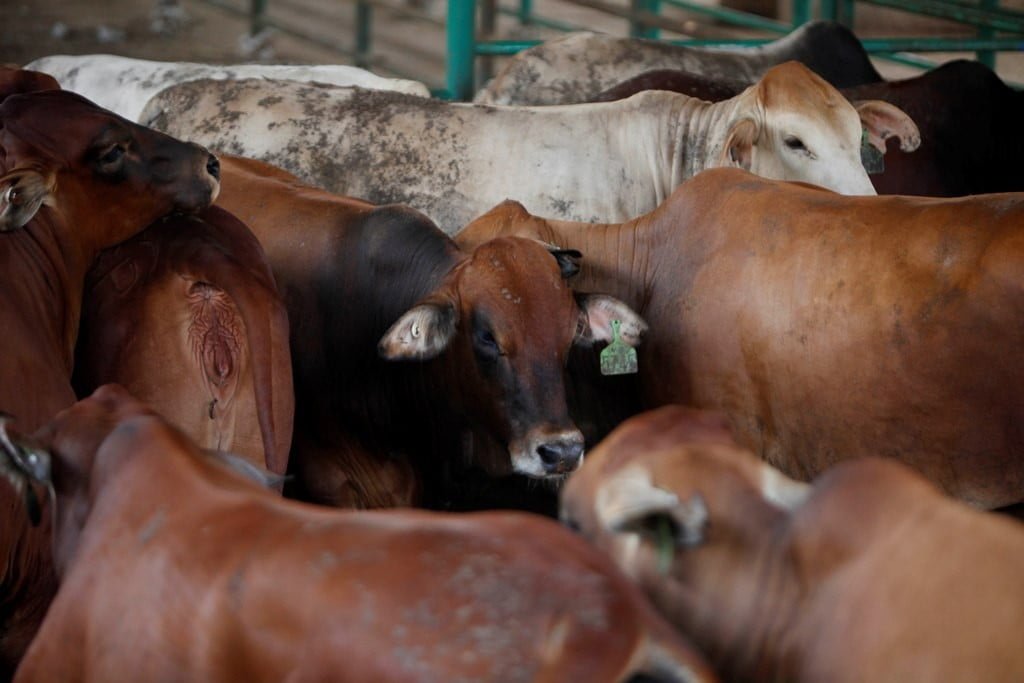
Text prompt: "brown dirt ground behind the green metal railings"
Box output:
[[0, 0, 1024, 94]]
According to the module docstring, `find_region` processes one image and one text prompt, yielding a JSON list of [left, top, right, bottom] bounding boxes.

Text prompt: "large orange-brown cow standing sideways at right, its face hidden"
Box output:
[[459, 169, 1024, 508]]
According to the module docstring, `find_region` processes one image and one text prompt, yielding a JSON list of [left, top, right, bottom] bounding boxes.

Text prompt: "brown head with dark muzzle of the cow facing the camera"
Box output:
[[379, 238, 645, 477]]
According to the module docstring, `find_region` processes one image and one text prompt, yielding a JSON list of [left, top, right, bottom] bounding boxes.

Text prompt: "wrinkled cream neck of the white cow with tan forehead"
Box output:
[[676, 88, 754, 185]]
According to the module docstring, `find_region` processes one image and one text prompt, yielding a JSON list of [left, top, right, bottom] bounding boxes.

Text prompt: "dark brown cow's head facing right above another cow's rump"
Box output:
[[0, 90, 219, 250]]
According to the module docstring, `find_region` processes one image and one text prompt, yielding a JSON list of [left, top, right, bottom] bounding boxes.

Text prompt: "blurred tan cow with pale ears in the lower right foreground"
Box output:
[[561, 405, 1024, 683]]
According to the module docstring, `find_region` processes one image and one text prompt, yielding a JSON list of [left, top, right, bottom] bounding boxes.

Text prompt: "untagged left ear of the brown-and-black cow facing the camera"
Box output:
[[377, 300, 459, 360]]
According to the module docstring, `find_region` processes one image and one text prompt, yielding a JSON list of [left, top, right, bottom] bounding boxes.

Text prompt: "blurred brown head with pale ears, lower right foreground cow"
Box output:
[[559, 405, 810, 655]]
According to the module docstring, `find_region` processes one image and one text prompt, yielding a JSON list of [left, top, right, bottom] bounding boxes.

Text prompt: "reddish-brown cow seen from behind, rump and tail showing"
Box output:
[[75, 207, 294, 474]]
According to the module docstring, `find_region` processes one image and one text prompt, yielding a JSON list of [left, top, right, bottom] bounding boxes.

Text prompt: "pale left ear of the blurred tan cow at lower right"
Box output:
[[595, 467, 709, 548]]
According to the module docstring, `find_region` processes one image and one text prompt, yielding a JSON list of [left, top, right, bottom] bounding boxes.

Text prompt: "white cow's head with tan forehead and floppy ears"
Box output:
[[718, 61, 921, 195]]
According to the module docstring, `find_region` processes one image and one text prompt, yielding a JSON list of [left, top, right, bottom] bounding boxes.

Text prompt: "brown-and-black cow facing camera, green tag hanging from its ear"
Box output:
[[212, 157, 643, 512]]
